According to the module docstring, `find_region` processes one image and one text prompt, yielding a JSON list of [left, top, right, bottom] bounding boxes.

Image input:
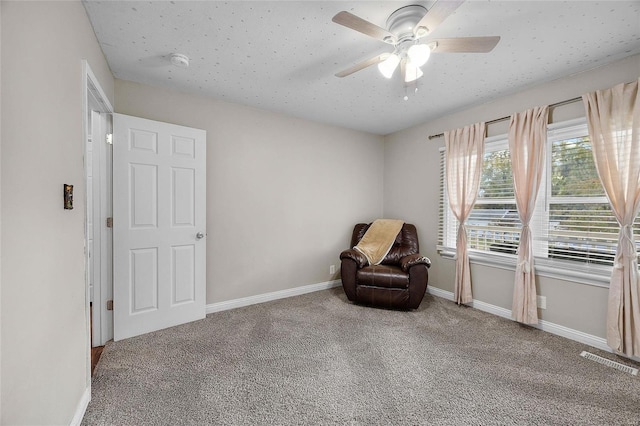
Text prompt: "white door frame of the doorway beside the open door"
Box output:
[[82, 59, 113, 387]]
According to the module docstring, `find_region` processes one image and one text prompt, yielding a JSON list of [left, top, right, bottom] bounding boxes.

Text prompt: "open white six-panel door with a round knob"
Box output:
[[113, 114, 206, 340]]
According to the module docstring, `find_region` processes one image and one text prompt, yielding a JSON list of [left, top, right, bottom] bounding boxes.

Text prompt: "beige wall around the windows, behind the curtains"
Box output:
[[384, 56, 640, 337]]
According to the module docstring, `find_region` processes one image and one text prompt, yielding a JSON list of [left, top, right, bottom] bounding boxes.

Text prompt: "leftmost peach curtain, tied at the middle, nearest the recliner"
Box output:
[[444, 123, 485, 304]]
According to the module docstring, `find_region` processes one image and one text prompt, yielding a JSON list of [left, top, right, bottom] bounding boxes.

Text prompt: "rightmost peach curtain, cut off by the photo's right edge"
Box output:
[[582, 79, 640, 356]]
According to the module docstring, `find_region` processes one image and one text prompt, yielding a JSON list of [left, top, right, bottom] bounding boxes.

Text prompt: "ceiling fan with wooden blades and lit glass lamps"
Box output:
[[332, 0, 500, 83]]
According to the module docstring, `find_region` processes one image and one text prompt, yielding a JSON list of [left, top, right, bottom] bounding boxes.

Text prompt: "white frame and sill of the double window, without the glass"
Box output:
[[436, 117, 612, 287]]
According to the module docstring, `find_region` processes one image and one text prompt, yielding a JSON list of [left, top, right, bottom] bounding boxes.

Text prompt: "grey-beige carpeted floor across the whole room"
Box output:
[[83, 288, 640, 425]]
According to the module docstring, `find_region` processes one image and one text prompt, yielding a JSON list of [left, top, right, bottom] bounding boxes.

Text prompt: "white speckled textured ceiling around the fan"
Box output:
[[84, 0, 640, 134]]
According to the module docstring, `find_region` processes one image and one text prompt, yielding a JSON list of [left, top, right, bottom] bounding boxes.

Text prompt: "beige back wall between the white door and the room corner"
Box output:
[[115, 80, 384, 304]]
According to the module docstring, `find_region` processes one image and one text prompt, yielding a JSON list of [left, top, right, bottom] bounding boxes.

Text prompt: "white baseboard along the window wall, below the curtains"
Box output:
[[427, 287, 608, 359]]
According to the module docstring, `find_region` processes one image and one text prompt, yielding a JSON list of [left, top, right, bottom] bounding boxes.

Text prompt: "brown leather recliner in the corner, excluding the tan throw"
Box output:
[[340, 223, 431, 309]]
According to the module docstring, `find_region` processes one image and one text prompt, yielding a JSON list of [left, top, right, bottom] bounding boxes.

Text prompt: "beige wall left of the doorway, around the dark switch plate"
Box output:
[[0, 1, 113, 425]]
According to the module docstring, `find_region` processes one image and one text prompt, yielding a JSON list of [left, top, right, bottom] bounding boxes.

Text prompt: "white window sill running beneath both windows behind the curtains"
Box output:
[[438, 247, 611, 288]]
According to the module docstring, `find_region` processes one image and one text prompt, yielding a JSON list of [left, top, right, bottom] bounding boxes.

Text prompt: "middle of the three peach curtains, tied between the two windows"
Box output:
[[509, 106, 549, 324]]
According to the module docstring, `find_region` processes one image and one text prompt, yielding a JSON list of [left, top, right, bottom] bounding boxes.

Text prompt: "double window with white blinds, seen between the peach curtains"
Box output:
[[439, 119, 640, 281]]
